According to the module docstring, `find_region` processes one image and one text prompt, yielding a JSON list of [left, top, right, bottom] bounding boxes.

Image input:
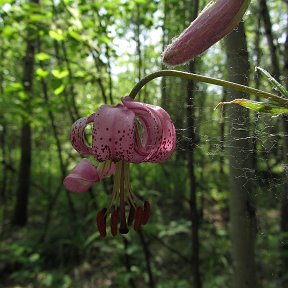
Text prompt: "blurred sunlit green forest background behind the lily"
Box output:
[[0, 0, 288, 288]]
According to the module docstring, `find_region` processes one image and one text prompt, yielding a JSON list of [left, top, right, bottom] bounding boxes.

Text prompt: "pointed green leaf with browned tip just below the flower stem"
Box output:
[[216, 99, 288, 115]]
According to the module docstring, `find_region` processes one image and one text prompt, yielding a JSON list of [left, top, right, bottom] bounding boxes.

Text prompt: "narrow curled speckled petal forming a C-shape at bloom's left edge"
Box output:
[[70, 114, 95, 155]]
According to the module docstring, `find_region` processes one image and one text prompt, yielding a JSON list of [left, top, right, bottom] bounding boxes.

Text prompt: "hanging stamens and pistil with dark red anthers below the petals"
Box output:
[[96, 161, 151, 237]]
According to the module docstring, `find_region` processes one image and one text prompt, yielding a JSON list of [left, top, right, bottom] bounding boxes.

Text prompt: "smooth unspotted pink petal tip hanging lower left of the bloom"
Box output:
[[63, 159, 101, 193]]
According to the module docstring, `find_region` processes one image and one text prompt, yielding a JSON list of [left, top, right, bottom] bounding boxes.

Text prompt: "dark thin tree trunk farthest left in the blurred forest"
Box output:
[[12, 0, 39, 227]]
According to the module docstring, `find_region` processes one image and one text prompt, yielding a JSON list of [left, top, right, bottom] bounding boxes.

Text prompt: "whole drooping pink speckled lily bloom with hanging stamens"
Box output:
[[64, 97, 176, 236]]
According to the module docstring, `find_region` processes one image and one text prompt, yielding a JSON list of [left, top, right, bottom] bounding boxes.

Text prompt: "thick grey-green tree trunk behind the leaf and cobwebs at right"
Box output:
[[225, 22, 257, 288]]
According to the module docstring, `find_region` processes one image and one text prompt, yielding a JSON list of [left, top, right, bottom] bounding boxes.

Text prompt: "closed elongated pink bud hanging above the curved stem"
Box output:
[[163, 0, 251, 65]]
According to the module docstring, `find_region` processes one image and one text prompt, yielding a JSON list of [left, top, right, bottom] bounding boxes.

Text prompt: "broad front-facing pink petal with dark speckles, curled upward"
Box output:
[[92, 104, 135, 162]]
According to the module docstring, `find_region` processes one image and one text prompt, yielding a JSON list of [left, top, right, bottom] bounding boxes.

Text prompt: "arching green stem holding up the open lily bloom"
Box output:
[[129, 70, 288, 106]]
